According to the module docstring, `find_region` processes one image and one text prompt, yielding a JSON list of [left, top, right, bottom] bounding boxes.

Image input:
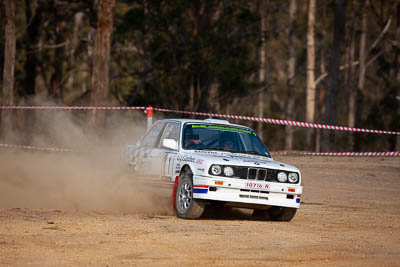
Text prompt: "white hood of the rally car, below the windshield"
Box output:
[[185, 150, 300, 172]]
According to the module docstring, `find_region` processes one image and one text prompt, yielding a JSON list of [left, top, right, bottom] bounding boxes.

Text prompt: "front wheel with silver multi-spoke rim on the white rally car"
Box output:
[[175, 174, 205, 219]]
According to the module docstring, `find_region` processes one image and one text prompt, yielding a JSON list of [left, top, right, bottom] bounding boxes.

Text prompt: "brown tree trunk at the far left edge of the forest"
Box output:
[[1, 0, 16, 141]]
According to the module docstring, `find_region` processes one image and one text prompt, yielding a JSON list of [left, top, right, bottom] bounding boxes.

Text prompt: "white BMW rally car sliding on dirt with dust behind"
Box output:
[[124, 119, 303, 221]]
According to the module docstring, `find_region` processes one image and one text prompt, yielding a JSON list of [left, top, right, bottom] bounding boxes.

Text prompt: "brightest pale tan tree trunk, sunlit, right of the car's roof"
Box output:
[[306, 0, 315, 149]]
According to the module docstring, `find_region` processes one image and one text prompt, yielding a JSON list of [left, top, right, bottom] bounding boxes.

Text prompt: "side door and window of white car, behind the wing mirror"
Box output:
[[150, 122, 180, 177]]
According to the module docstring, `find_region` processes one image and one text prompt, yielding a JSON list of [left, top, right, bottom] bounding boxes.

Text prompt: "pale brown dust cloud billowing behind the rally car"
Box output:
[[0, 104, 171, 214]]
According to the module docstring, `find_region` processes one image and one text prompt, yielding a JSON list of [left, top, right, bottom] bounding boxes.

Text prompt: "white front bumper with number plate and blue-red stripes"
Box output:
[[193, 175, 303, 208]]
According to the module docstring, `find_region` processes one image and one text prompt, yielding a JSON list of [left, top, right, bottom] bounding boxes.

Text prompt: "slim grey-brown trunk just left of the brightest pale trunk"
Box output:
[[285, 0, 297, 150]]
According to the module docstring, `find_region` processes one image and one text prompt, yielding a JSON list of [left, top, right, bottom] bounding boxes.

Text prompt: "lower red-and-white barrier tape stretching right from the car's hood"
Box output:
[[271, 151, 400, 157]]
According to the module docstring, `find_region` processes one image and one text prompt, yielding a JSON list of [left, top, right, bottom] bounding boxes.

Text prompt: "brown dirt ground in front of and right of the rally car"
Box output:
[[0, 157, 400, 266]]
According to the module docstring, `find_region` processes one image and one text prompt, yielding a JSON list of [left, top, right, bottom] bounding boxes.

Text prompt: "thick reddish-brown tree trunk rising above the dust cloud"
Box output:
[[90, 0, 116, 128]]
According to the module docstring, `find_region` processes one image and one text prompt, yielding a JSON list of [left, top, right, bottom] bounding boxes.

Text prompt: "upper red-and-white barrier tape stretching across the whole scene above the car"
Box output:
[[0, 106, 400, 135]]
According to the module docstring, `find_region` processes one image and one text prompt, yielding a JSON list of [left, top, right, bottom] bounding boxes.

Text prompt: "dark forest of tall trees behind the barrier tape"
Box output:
[[0, 0, 400, 151]]
